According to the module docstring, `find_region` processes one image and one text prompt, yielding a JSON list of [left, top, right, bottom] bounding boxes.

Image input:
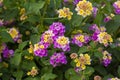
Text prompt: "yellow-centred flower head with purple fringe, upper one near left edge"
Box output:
[[8, 28, 21, 42]]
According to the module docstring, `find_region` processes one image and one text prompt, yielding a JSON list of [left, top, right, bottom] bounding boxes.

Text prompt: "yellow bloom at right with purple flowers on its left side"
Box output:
[[90, 24, 113, 46]]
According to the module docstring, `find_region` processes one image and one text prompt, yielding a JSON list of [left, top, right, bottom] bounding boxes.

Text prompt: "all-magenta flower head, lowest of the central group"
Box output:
[[50, 52, 67, 67]]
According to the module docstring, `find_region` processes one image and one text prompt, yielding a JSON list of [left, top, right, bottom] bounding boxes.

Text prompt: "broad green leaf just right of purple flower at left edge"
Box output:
[[11, 53, 22, 66]]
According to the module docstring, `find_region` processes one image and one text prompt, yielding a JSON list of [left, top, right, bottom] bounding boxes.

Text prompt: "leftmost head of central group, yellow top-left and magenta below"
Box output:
[[34, 41, 48, 58]]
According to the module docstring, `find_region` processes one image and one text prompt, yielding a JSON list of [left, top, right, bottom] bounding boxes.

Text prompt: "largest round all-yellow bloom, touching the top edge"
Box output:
[[75, 0, 93, 17]]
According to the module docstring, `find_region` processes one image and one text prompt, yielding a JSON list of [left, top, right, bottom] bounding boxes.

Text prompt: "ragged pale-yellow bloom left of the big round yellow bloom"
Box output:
[[57, 7, 73, 20]]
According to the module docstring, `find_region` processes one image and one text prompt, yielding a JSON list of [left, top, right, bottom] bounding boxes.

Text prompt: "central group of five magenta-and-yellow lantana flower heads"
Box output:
[[34, 22, 70, 67]]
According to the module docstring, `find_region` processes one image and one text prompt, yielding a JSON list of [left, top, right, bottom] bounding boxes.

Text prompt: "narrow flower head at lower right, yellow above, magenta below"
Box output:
[[102, 51, 112, 67]]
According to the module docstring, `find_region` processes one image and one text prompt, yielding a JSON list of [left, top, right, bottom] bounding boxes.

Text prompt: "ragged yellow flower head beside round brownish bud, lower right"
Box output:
[[73, 54, 91, 70]]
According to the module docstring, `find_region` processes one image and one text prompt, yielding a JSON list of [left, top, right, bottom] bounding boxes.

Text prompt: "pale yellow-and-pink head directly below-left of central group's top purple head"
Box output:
[[41, 30, 55, 46]]
